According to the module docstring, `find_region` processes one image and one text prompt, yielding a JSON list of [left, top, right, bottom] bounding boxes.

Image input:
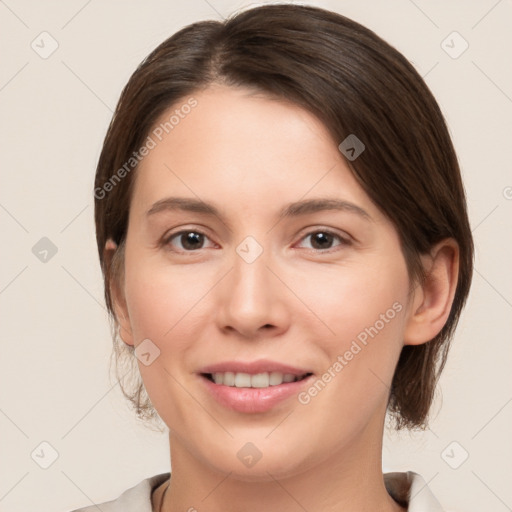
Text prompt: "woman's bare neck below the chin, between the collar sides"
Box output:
[[161, 412, 405, 512]]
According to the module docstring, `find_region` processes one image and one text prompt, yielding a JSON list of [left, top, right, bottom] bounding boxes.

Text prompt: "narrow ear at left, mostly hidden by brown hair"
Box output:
[[103, 238, 134, 345]]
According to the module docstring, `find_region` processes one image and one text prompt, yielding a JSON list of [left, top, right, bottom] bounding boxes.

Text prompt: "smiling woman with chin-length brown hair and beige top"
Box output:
[[71, 5, 473, 512]]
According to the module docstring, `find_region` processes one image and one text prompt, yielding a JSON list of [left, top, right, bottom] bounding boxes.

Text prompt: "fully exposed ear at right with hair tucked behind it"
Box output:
[[404, 238, 459, 345]]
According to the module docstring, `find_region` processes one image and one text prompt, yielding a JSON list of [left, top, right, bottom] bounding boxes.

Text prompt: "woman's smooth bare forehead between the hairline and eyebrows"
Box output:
[[130, 86, 380, 219]]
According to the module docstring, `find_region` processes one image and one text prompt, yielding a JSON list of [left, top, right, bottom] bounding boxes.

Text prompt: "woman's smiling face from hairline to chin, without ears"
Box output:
[[117, 86, 416, 479]]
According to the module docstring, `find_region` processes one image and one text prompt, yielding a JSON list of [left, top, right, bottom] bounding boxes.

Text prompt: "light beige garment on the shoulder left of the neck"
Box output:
[[67, 473, 170, 512]]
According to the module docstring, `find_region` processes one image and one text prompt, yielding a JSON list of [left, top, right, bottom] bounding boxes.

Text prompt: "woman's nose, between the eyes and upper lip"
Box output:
[[216, 244, 290, 339]]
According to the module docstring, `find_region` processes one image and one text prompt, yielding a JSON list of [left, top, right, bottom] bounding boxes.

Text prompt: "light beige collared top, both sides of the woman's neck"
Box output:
[[68, 471, 443, 512]]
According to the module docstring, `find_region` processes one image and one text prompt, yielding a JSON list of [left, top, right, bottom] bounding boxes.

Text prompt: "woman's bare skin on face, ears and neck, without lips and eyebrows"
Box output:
[[105, 85, 458, 512]]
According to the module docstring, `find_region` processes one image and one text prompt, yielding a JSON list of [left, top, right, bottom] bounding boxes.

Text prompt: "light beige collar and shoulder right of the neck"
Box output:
[[384, 471, 443, 512]]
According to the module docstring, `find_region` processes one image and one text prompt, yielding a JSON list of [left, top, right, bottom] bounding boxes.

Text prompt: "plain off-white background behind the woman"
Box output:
[[0, 0, 512, 512]]
